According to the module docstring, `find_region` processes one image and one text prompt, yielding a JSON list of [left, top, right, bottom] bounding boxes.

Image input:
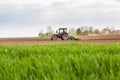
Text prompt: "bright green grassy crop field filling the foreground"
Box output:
[[0, 43, 120, 80]]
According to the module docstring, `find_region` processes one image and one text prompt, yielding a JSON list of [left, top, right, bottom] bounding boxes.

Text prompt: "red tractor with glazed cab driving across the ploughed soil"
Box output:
[[51, 28, 69, 40]]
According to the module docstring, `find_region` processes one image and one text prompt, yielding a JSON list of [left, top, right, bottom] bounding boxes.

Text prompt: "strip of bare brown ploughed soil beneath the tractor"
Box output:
[[0, 34, 120, 45]]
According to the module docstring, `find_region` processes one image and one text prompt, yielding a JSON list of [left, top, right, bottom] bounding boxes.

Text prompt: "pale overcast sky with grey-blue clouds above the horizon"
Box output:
[[0, 0, 120, 37]]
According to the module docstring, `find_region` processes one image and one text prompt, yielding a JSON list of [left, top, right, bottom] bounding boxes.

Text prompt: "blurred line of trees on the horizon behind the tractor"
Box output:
[[38, 26, 114, 38]]
